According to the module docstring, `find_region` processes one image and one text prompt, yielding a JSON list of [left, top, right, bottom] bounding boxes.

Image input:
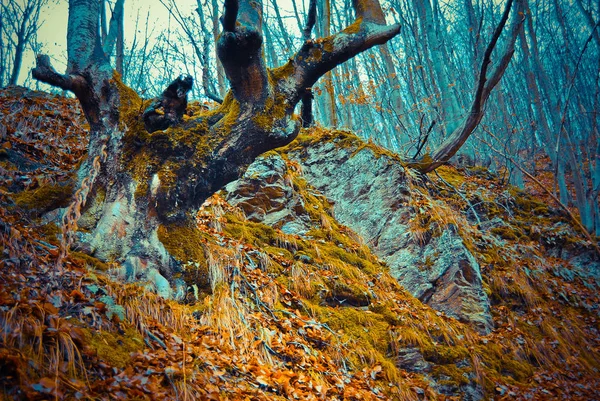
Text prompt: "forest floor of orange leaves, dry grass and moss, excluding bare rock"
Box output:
[[0, 88, 600, 400]]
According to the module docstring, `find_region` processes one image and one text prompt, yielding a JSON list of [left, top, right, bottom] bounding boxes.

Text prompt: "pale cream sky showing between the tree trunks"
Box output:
[[19, 0, 300, 89]]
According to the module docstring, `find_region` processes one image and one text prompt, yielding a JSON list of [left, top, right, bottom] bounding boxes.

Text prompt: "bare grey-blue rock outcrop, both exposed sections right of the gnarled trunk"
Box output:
[[227, 133, 493, 332]]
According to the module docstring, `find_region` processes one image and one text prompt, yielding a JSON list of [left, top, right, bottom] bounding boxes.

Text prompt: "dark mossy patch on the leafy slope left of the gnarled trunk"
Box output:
[[13, 182, 73, 215]]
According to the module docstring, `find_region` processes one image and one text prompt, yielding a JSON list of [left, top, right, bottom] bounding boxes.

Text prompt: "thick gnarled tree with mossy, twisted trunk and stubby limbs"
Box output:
[[32, 0, 400, 296]]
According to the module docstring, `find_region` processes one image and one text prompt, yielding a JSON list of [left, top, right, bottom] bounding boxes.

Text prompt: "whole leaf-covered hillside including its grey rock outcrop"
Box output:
[[0, 87, 600, 400]]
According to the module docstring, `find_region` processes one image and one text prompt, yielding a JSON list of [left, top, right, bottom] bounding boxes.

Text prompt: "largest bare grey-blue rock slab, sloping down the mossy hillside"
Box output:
[[289, 142, 493, 333]]
